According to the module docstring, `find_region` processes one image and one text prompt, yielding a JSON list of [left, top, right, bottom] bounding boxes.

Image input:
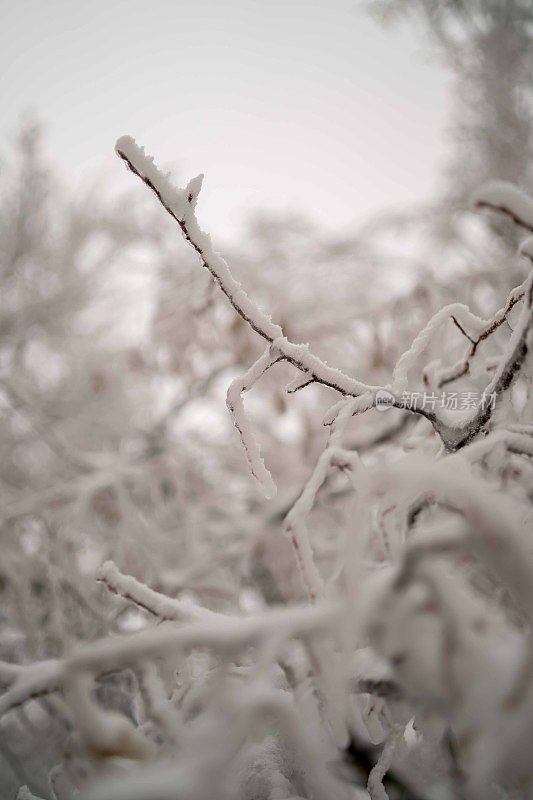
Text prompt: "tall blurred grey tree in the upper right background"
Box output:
[[369, 0, 533, 272]]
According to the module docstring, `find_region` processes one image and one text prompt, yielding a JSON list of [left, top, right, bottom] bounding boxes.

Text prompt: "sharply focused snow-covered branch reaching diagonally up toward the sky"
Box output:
[[116, 136, 533, 494]]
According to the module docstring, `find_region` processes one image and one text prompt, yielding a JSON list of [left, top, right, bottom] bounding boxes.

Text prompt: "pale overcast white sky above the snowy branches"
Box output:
[[0, 0, 449, 237]]
